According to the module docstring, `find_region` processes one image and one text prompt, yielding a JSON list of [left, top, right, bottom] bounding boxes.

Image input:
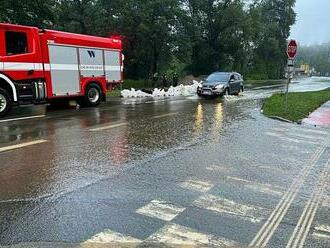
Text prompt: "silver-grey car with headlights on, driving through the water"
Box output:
[[197, 72, 244, 97]]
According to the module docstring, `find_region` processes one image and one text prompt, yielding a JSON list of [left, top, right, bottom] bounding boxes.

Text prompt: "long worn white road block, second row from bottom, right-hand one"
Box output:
[[194, 194, 266, 223]]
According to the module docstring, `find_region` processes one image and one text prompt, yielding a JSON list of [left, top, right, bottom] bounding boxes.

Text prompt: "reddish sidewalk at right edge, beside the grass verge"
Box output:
[[302, 101, 330, 127]]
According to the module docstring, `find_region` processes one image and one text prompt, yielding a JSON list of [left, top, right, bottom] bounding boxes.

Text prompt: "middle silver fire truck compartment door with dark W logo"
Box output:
[[79, 48, 104, 77]]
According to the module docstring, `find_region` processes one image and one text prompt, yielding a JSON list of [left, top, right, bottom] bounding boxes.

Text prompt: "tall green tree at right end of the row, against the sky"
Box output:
[[250, 0, 296, 78]]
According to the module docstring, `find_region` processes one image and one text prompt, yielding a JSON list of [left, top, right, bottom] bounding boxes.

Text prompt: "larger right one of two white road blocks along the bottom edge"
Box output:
[[146, 224, 240, 247]]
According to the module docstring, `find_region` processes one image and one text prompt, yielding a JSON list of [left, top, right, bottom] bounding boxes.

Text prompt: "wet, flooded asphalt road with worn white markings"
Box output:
[[0, 78, 330, 247]]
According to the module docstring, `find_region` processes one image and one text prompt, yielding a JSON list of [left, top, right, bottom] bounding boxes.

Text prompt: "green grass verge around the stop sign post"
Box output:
[[263, 88, 330, 122]]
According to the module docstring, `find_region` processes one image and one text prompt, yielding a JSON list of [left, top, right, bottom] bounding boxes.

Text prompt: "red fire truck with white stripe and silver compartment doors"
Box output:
[[0, 23, 123, 117]]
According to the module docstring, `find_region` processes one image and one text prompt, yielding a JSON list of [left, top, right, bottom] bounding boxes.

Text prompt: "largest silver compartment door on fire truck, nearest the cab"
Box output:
[[49, 45, 80, 96]]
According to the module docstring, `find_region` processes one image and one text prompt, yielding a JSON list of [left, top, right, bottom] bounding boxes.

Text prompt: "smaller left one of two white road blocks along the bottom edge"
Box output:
[[83, 230, 142, 247]]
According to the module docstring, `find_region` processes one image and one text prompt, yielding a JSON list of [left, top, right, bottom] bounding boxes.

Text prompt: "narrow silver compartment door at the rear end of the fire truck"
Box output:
[[104, 51, 121, 82]]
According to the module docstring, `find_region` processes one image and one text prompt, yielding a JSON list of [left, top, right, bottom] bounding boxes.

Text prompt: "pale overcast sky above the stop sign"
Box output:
[[291, 0, 330, 45]]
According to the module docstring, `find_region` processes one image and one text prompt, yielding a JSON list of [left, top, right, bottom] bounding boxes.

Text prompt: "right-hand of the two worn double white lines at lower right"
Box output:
[[286, 160, 330, 248]]
